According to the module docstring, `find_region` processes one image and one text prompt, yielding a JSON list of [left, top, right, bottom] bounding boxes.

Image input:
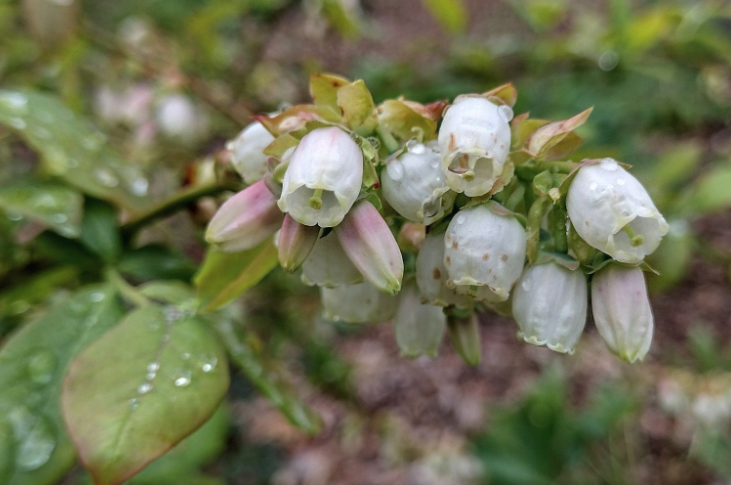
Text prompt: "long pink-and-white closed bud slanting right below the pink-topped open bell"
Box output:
[[335, 200, 404, 295]]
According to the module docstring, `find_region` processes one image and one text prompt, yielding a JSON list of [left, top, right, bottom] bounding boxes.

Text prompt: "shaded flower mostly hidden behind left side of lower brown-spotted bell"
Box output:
[[416, 233, 473, 309]]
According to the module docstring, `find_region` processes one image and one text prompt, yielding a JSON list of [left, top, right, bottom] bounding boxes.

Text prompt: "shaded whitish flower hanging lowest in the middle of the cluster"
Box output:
[[393, 284, 447, 358]]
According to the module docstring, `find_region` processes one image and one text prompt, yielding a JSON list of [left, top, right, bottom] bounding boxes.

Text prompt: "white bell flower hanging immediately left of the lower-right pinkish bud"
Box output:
[[513, 261, 588, 354]]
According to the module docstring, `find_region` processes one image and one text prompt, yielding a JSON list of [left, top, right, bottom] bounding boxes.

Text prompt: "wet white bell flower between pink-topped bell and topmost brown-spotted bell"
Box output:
[[381, 141, 454, 225]]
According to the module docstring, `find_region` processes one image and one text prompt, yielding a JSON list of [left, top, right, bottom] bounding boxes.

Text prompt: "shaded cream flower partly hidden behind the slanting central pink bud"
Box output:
[[302, 233, 363, 288]]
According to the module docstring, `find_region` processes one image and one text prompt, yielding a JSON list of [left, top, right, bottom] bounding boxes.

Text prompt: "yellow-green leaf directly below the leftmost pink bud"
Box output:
[[194, 238, 279, 312]]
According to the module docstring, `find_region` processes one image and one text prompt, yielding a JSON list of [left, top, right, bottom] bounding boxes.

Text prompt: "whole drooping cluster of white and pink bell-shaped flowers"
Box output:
[[206, 74, 668, 363]]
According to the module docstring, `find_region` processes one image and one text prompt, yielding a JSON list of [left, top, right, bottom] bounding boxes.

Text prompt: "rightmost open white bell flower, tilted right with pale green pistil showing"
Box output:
[[566, 158, 668, 263]]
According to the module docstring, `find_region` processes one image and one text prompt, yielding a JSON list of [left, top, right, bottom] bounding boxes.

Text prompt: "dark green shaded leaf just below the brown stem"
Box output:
[[117, 244, 197, 281]]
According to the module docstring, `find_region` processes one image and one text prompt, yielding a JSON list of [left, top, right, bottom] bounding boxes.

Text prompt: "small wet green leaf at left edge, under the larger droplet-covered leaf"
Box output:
[[0, 179, 84, 237]]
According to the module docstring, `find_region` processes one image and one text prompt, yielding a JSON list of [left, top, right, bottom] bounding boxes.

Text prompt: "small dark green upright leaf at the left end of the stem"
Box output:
[[80, 198, 122, 261]]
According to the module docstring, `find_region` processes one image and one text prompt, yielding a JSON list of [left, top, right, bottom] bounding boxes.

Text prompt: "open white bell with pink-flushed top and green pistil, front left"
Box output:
[[279, 128, 363, 227]]
